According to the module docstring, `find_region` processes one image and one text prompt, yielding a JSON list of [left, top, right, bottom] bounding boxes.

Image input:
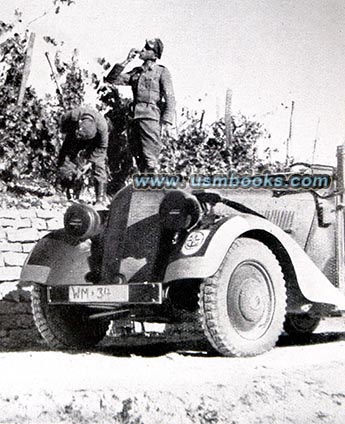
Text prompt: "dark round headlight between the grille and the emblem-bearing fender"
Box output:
[[159, 190, 201, 231]]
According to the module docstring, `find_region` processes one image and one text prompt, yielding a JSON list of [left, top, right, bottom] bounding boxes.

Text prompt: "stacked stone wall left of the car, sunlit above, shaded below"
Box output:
[[0, 205, 65, 350]]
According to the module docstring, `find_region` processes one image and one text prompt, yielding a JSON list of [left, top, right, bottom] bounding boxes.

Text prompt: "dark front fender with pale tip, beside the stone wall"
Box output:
[[19, 230, 91, 286]]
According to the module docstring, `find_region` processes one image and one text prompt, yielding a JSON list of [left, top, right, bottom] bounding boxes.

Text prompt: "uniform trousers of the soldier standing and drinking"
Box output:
[[128, 119, 162, 172]]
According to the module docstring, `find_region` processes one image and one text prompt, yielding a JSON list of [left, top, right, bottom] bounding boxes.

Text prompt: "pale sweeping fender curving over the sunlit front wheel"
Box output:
[[164, 215, 345, 310]]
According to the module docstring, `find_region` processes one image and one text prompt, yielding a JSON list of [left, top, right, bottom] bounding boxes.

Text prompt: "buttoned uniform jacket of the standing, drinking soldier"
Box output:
[[106, 63, 175, 124]]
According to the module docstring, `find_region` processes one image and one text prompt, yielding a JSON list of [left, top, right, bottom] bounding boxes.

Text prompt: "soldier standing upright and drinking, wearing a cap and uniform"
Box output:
[[105, 38, 175, 172]]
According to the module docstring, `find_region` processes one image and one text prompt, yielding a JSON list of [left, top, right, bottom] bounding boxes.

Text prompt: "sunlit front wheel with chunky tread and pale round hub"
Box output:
[[199, 238, 286, 356]]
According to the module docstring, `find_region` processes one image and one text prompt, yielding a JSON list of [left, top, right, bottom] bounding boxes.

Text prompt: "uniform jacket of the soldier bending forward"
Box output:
[[58, 106, 109, 167]]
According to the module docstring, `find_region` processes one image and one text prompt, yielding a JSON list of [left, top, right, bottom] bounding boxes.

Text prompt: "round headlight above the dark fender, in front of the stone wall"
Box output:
[[64, 203, 101, 239]]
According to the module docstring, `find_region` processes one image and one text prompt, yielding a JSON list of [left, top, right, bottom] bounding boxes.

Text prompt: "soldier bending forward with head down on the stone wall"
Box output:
[[58, 106, 109, 206]]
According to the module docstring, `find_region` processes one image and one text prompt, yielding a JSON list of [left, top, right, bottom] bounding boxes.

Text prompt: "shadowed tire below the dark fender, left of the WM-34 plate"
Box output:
[[31, 284, 109, 349]]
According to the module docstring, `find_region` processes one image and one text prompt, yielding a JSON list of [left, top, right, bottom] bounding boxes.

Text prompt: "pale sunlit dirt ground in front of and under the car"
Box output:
[[0, 319, 345, 424]]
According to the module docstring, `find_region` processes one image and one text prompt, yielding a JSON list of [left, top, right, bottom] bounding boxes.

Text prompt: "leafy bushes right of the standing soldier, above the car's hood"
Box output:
[[161, 111, 281, 176]]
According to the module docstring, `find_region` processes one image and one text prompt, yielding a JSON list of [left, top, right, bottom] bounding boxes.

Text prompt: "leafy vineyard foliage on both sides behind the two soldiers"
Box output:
[[0, 9, 280, 196]]
